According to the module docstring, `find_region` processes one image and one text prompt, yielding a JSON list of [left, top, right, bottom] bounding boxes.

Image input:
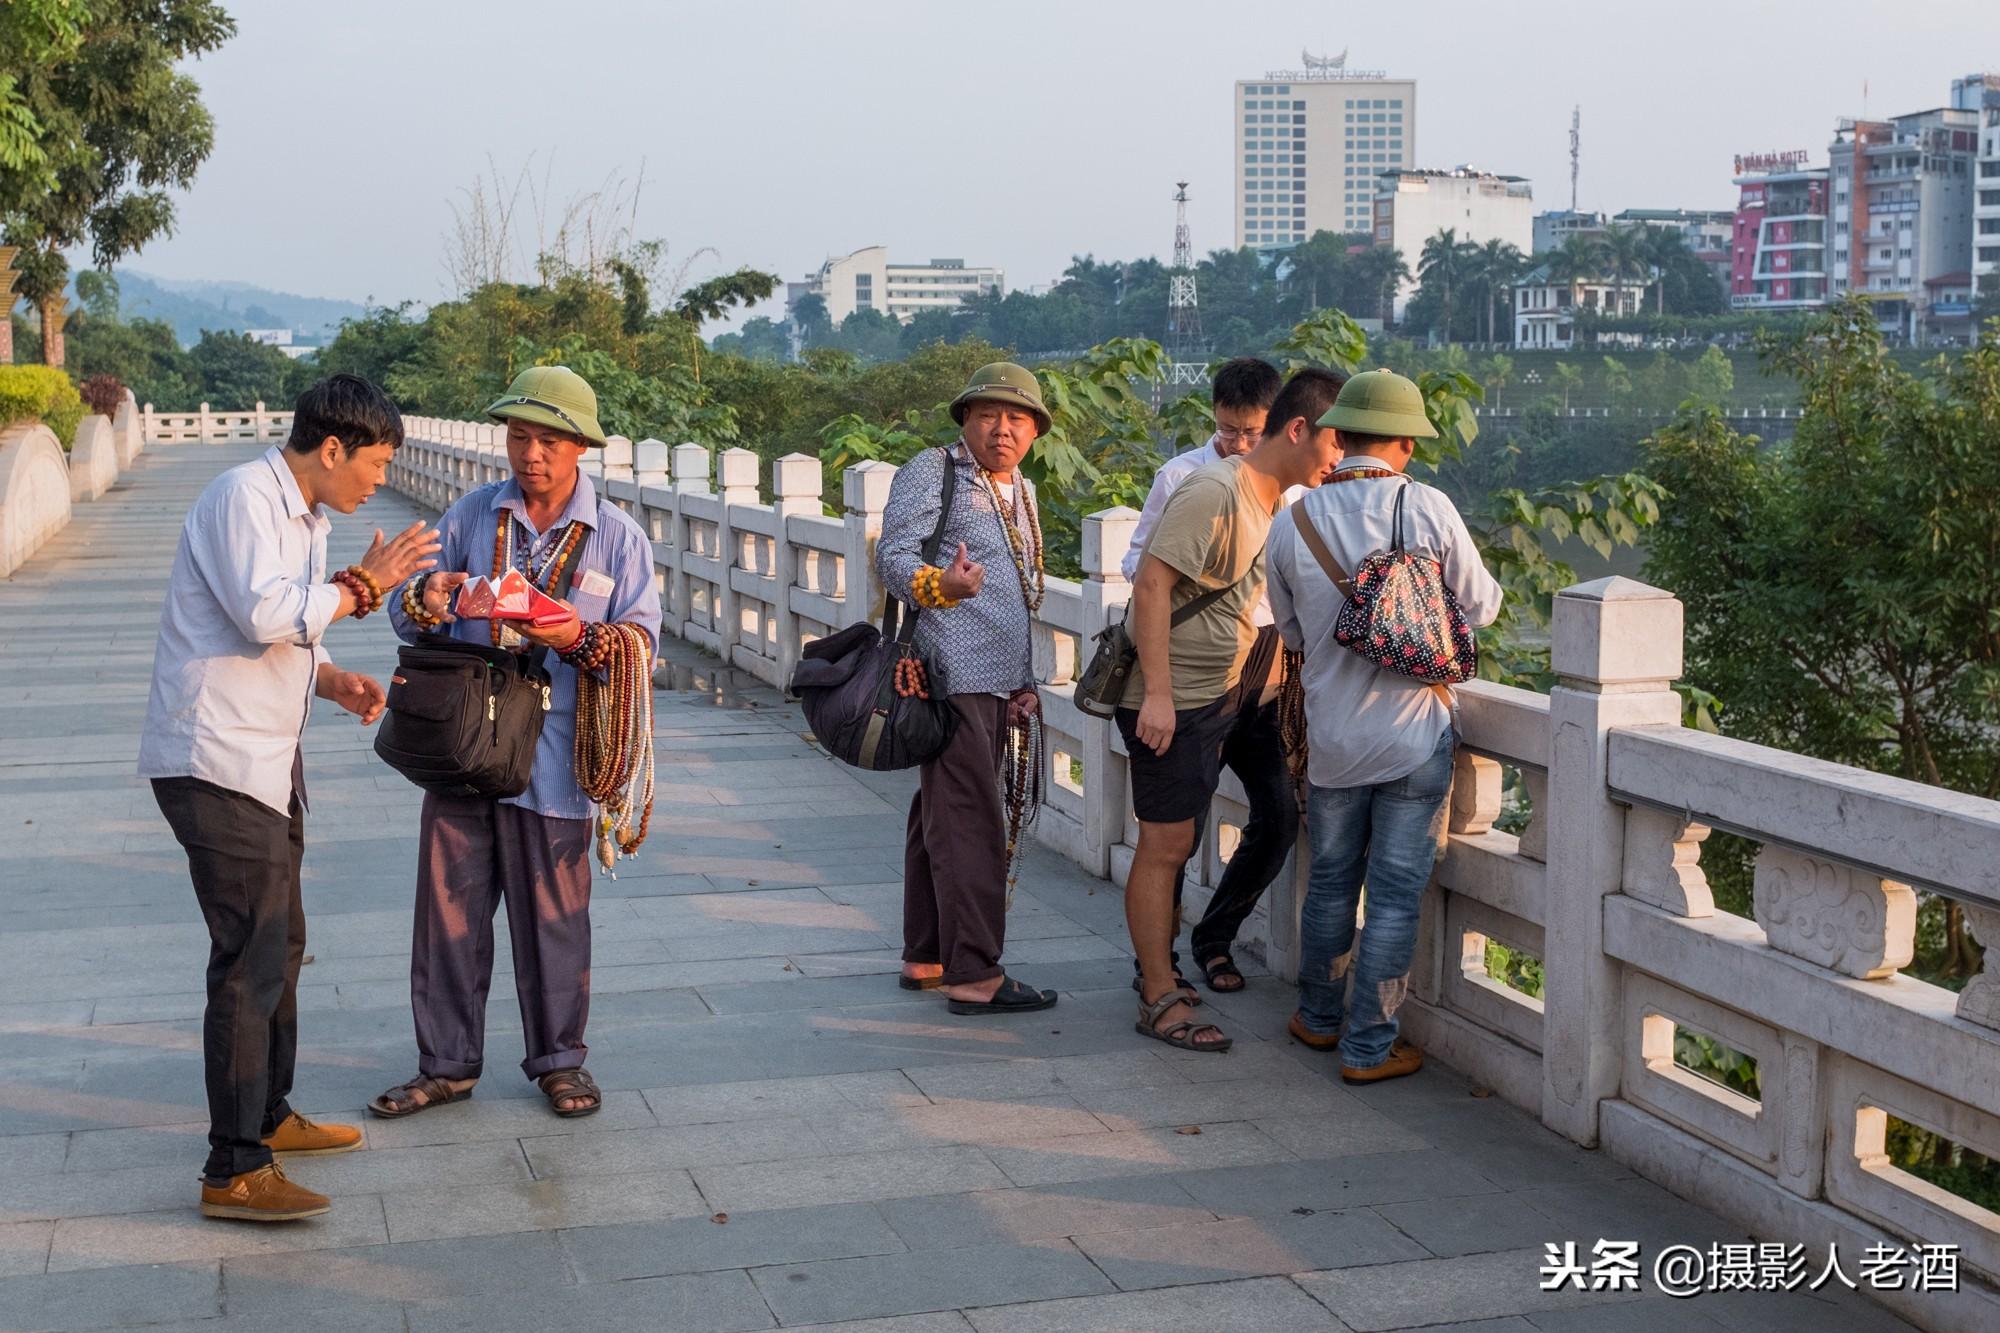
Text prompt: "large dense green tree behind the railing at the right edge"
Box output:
[[1646, 300, 2000, 979]]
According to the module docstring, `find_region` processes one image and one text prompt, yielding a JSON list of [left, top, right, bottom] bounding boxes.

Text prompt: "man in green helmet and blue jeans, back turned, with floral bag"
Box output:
[[1266, 370, 1500, 1083]]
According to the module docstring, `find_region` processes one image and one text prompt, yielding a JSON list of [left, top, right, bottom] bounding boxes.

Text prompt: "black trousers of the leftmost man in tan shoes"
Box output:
[[152, 777, 306, 1177]]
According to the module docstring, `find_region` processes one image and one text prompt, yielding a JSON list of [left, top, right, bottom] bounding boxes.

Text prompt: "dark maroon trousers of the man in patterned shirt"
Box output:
[[902, 695, 1006, 987]]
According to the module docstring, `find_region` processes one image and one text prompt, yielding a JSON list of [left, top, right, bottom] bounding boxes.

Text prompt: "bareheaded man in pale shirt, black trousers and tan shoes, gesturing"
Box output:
[[138, 374, 438, 1221]]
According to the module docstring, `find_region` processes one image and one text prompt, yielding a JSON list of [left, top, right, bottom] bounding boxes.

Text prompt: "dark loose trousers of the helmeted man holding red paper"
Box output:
[[410, 793, 590, 1079]]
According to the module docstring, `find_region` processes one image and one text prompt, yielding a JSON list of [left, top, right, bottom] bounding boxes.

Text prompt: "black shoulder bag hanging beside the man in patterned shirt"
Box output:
[[790, 450, 958, 773]]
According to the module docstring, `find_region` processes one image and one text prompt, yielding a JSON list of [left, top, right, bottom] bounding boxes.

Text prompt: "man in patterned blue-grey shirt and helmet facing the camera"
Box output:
[[876, 362, 1056, 1015]]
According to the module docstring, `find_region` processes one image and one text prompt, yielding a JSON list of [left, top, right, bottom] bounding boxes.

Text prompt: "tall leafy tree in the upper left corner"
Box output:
[[0, 0, 236, 366]]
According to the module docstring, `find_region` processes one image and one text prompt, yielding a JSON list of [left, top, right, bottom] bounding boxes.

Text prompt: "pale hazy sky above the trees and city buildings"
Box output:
[[132, 0, 2000, 322]]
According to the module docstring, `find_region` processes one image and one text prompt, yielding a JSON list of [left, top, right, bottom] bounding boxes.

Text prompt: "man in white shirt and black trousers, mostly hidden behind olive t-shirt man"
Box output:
[[1122, 356, 1340, 993]]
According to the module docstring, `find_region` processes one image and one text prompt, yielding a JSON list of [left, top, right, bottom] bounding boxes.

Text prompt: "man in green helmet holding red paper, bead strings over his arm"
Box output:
[[368, 366, 660, 1119]]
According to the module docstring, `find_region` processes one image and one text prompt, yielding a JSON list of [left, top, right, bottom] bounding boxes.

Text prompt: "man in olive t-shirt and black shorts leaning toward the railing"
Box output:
[[1116, 372, 1340, 1051]]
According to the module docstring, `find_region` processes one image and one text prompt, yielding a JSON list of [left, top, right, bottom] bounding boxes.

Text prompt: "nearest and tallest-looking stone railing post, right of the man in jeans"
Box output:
[[1536, 576, 1682, 1147]]
